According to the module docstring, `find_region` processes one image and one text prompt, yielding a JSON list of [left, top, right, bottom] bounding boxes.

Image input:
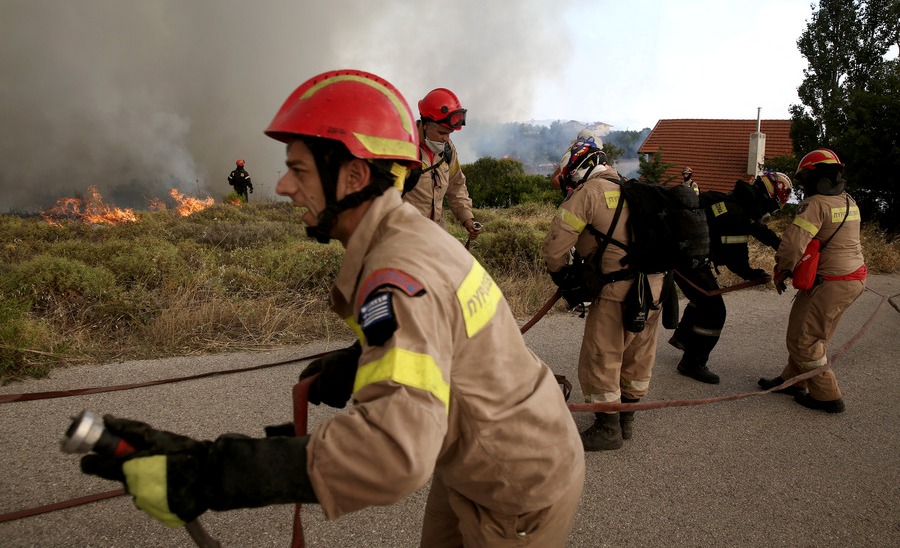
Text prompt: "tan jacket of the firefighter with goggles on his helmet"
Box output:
[[403, 141, 474, 226]]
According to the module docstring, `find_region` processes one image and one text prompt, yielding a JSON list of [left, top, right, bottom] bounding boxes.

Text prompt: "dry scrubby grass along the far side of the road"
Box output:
[[0, 204, 900, 383]]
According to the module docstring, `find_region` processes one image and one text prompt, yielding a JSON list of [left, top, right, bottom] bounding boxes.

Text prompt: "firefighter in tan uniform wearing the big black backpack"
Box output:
[[542, 141, 663, 451]]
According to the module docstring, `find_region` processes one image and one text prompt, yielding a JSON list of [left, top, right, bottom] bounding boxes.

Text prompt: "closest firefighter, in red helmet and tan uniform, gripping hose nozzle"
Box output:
[[82, 70, 584, 547]]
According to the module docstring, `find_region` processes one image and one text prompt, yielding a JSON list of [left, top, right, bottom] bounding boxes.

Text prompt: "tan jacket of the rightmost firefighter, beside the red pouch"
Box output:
[[775, 192, 864, 276]]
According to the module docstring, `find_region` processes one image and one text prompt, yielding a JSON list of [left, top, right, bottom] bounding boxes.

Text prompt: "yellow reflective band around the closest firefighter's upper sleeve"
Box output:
[[353, 348, 450, 412]]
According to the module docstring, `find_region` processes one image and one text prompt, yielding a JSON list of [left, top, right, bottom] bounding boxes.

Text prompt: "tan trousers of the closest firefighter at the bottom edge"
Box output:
[[419, 460, 584, 548]]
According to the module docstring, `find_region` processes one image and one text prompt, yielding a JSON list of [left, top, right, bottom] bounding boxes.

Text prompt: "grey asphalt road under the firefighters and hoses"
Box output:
[[0, 275, 900, 548]]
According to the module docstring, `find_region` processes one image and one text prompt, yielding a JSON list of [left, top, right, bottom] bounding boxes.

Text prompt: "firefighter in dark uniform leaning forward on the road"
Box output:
[[669, 171, 792, 384]]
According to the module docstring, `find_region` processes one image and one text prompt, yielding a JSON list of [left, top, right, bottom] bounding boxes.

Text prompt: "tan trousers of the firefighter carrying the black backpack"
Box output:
[[578, 299, 660, 403]]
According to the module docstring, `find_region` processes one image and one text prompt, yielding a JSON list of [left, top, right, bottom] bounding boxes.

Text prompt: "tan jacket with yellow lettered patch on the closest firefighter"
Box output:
[[307, 189, 584, 519]]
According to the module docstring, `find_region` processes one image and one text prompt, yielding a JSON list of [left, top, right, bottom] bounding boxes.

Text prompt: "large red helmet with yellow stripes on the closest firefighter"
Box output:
[[265, 70, 421, 167]]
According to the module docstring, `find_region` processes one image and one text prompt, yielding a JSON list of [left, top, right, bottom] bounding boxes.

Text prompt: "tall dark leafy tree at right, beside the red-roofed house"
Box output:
[[790, 0, 900, 230]]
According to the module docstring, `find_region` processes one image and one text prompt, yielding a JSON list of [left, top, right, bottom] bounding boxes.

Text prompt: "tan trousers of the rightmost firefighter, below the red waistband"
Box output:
[[781, 280, 866, 401]]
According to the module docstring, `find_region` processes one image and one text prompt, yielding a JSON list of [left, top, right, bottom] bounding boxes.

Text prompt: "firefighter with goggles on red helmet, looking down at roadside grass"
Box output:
[[403, 88, 481, 240]]
